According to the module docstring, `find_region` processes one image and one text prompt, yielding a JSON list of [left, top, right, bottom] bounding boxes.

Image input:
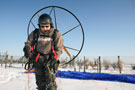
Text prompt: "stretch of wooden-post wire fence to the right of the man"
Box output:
[[62, 56, 135, 74]]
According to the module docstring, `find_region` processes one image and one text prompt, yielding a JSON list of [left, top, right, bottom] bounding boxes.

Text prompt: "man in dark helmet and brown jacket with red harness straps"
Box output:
[[23, 14, 64, 90]]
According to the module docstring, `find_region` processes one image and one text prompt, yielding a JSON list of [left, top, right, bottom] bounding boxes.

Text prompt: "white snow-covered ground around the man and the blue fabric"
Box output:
[[0, 65, 135, 90]]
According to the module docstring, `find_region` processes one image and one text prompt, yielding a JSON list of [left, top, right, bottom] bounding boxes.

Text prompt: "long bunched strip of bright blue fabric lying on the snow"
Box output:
[[56, 70, 135, 83]]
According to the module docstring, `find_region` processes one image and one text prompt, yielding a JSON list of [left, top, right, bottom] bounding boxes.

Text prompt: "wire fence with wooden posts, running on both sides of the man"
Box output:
[[0, 52, 135, 73]]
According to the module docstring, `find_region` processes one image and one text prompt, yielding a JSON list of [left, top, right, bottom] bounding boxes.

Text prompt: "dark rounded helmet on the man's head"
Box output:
[[38, 14, 52, 25]]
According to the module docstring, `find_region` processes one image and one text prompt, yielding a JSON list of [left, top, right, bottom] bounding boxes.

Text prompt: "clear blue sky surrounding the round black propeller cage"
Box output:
[[0, 0, 135, 57]]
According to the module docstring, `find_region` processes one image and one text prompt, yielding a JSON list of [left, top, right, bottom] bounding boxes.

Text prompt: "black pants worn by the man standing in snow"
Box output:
[[35, 56, 57, 90]]
